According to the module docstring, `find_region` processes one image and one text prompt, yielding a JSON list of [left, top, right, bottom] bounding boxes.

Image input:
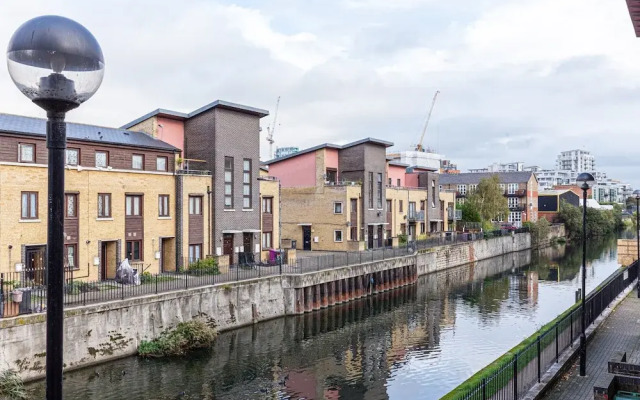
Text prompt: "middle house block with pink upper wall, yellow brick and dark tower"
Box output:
[[265, 138, 392, 250]]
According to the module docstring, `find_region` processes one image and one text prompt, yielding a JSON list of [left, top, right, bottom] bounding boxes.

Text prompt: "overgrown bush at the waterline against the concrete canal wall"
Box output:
[[138, 319, 217, 357]]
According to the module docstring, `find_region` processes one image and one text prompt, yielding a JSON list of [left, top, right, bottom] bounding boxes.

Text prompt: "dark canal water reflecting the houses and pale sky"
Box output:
[[29, 237, 619, 400]]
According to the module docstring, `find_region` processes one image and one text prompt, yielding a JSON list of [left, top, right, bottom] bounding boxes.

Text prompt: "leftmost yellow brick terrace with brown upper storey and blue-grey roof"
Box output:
[[0, 114, 211, 280]]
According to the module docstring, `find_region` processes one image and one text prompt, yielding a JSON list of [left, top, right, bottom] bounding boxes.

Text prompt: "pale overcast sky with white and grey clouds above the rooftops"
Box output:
[[0, 0, 640, 187]]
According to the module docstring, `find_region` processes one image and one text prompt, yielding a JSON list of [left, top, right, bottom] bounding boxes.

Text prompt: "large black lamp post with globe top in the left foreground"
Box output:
[[7, 15, 104, 400]]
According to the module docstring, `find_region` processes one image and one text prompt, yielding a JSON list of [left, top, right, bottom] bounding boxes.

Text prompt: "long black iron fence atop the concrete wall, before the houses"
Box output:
[[0, 229, 526, 318]]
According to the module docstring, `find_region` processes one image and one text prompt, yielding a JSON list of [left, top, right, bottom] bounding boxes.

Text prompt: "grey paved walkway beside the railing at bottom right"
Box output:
[[544, 290, 640, 400]]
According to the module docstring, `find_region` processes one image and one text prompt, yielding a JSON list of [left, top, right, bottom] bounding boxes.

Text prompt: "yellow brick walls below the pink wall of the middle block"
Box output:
[[281, 185, 362, 251]]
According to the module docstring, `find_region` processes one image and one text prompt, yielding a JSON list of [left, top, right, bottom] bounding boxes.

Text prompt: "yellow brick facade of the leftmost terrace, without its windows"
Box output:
[[0, 164, 211, 280]]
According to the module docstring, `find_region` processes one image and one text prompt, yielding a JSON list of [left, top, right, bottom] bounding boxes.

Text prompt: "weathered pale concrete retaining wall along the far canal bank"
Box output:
[[0, 233, 531, 380]]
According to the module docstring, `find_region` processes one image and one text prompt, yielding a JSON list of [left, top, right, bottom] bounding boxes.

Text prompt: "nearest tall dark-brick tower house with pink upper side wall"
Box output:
[[123, 100, 268, 263]]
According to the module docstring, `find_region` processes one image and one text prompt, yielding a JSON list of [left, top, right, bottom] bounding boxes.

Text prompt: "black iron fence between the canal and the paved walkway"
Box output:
[[444, 261, 638, 400]]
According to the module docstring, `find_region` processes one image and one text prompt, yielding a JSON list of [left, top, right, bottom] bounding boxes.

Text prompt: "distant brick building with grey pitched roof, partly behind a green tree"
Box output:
[[440, 171, 538, 227]]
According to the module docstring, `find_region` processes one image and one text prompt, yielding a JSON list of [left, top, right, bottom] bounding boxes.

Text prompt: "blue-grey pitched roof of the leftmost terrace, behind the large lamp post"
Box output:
[[0, 114, 179, 152]]
